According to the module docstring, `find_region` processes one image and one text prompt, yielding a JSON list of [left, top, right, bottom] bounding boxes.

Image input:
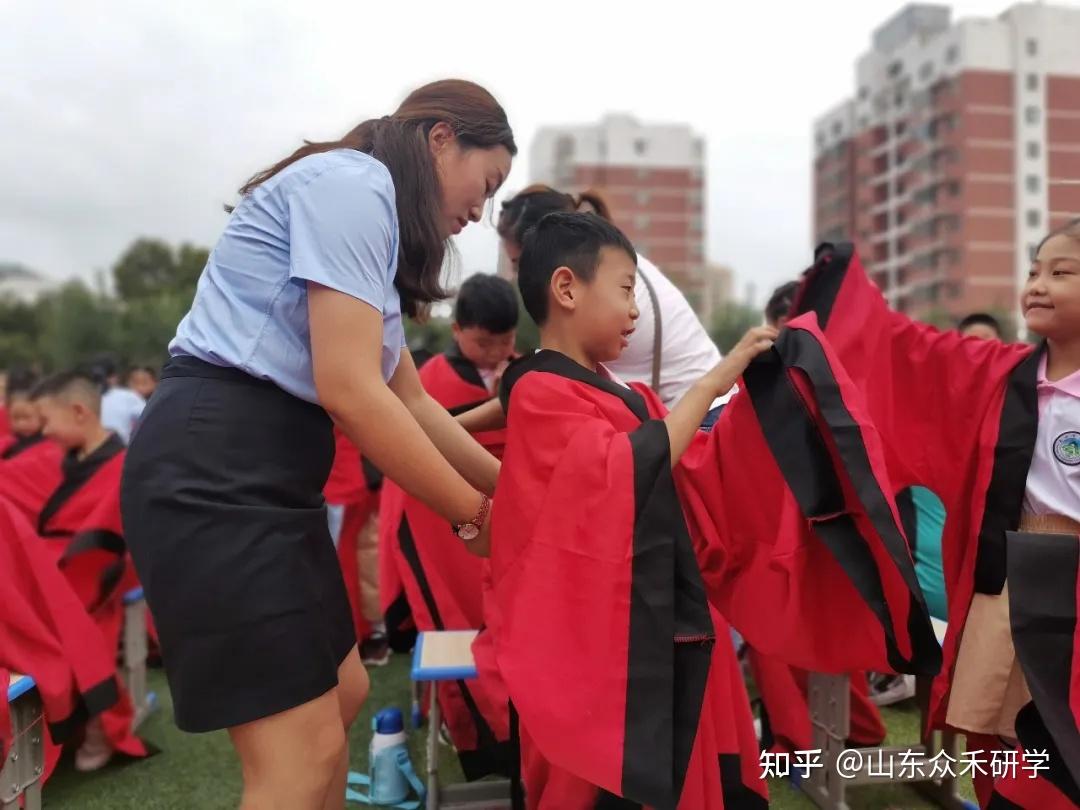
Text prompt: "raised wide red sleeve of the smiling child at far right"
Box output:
[[793, 243, 1034, 494]]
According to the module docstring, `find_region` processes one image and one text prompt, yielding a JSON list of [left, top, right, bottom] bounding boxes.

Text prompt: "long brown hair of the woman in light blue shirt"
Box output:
[[240, 79, 517, 318]]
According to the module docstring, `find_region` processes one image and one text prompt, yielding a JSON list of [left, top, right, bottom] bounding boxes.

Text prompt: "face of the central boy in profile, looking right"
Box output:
[[573, 247, 638, 363]]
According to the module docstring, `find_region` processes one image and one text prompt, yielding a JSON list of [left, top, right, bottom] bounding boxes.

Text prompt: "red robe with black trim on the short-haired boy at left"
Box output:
[[37, 434, 147, 756]]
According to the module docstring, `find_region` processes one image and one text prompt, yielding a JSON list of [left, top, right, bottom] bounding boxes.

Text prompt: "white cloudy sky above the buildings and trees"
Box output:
[[0, 0, 1008, 298]]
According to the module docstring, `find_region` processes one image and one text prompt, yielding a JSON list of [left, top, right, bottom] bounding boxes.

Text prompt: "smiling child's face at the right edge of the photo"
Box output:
[[1021, 234, 1080, 340]]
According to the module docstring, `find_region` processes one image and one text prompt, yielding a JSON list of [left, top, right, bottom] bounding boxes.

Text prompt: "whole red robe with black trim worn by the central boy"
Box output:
[[486, 323, 941, 810]]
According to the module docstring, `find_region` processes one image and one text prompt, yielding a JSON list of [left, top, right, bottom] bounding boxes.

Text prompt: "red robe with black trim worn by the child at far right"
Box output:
[[794, 243, 1080, 807]]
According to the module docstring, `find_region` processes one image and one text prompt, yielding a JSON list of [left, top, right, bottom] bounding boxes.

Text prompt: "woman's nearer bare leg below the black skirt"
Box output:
[[229, 689, 348, 810]]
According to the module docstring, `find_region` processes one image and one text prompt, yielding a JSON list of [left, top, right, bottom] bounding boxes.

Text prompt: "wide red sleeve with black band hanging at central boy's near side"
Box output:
[[486, 372, 714, 807]]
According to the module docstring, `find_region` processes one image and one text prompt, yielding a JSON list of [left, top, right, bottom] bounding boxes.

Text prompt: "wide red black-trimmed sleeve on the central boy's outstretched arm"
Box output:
[[678, 316, 941, 674]]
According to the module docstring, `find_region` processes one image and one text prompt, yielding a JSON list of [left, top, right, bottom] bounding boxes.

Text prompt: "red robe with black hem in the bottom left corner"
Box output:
[[0, 499, 132, 778]]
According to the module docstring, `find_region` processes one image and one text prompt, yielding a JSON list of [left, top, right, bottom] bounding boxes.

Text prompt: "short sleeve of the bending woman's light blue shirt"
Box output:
[[288, 165, 396, 312]]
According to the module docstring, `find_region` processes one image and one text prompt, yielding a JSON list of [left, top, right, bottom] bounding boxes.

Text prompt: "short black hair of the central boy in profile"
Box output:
[[517, 214, 637, 326]]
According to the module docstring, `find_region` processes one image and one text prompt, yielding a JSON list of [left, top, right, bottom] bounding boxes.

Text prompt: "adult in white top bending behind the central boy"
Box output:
[[498, 185, 734, 407]]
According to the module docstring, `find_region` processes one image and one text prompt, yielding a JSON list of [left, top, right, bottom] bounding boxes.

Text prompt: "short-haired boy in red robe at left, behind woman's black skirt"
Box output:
[[31, 372, 146, 771]]
